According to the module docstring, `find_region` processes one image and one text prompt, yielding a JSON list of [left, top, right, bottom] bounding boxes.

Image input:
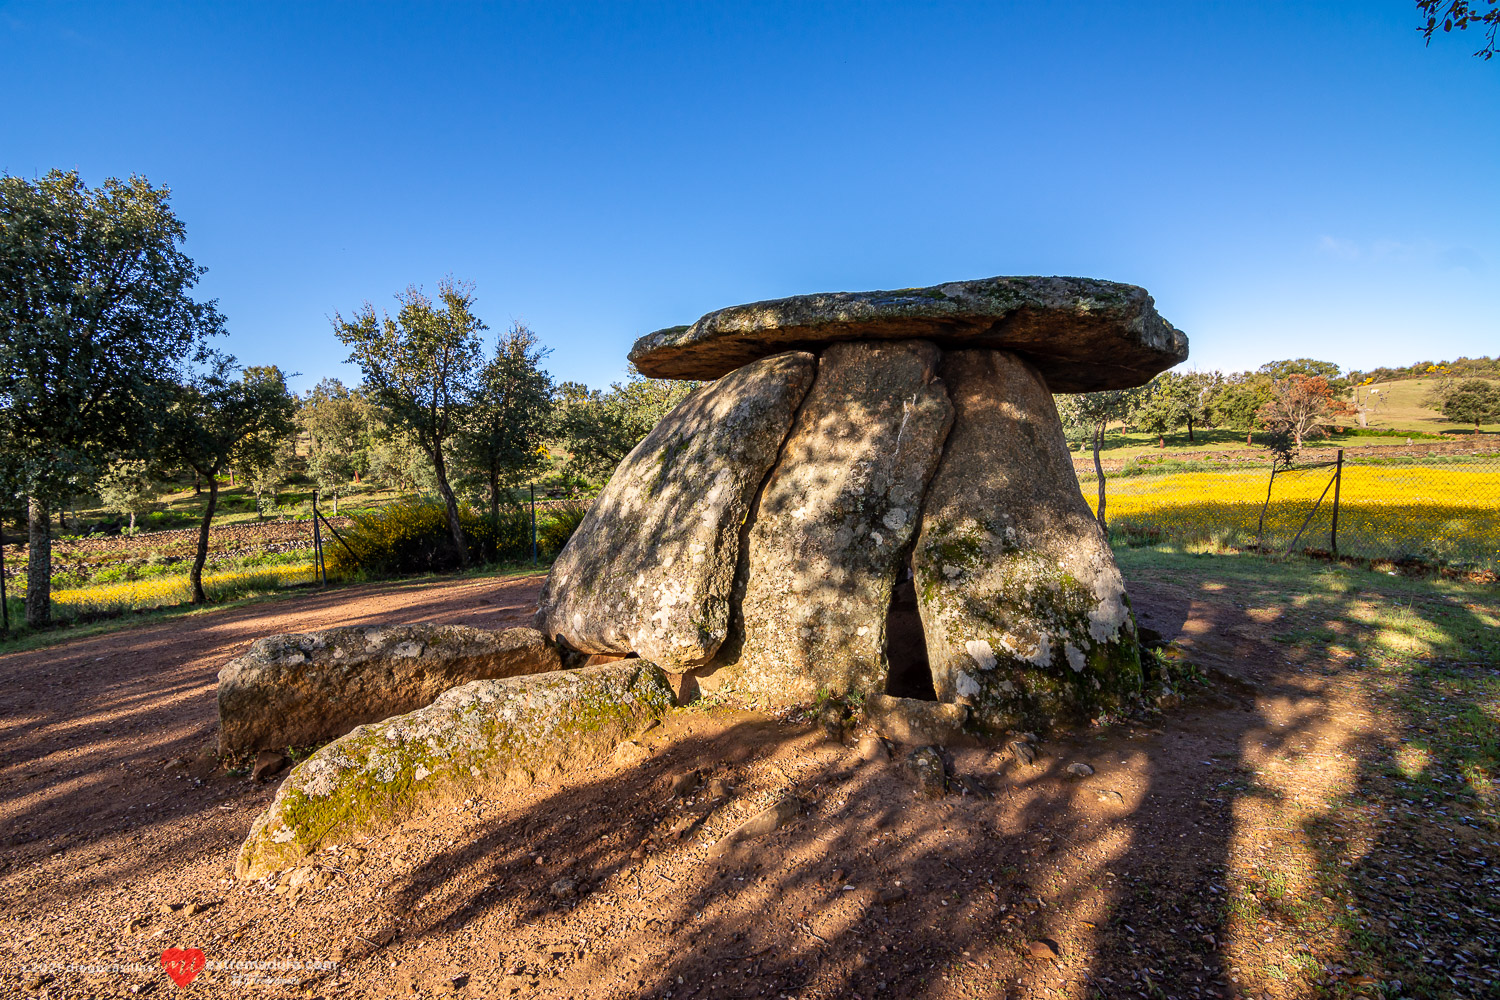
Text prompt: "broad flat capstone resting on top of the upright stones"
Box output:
[[630, 277, 1188, 393]]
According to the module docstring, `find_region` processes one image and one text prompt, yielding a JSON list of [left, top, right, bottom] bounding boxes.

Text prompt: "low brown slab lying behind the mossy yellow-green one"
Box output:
[[219, 625, 563, 754]]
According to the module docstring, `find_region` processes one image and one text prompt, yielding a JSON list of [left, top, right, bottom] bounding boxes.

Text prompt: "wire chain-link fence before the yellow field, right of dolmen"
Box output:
[[1080, 435, 1500, 571]]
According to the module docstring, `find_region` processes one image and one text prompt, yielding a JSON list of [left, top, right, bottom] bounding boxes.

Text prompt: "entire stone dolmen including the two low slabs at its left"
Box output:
[[234, 277, 1188, 879]]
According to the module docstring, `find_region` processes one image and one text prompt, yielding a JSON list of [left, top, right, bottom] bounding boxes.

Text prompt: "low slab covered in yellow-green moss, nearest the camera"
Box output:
[[234, 660, 672, 879]]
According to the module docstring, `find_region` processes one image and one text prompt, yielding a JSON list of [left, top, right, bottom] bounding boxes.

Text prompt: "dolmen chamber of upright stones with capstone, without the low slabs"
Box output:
[[537, 277, 1188, 732]]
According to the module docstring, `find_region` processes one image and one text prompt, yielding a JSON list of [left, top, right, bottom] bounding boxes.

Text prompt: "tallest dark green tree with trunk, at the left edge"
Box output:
[[0, 171, 224, 625]]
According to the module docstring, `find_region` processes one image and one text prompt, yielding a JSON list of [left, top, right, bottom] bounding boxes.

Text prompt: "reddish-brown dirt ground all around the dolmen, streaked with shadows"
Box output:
[[0, 558, 1500, 1000]]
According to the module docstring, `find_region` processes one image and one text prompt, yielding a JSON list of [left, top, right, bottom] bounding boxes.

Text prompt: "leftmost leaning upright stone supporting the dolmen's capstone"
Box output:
[[537, 351, 818, 670]]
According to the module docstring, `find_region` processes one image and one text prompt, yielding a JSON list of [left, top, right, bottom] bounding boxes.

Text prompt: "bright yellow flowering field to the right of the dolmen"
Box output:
[[1083, 462, 1500, 570]]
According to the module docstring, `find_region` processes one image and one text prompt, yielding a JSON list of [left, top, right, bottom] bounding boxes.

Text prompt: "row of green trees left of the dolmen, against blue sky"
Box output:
[[0, 171, 695, 625]]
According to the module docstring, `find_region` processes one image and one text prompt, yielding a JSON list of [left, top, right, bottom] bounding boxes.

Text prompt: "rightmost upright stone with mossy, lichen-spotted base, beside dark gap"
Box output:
[[912, 349, 1140, 729]]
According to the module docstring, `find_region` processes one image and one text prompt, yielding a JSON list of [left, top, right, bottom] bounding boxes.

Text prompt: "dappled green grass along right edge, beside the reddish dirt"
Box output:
[[1116, 547, 1500, 1000]]
